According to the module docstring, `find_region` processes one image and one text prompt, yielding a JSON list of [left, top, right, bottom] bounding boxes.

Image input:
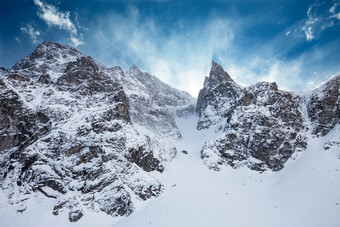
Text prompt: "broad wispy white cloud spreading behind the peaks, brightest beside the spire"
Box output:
[[84, 2, 334, 96]]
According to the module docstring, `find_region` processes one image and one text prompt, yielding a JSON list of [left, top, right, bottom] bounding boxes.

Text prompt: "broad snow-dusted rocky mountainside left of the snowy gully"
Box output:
[[0, 42, 186, 222]]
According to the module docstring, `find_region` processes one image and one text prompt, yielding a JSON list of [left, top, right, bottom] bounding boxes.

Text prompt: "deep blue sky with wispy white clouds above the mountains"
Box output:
[[0, 0, 340, 97]]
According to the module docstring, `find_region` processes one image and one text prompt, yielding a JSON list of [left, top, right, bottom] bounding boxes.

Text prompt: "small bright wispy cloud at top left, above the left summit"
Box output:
[[33, 0, 84, 46]]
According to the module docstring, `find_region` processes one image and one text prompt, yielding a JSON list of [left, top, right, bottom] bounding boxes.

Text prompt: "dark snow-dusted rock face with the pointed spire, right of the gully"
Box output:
[[196, 62, 340, 171]]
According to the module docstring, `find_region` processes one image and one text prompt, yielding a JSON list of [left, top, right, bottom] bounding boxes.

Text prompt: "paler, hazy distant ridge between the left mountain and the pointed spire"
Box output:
[[107, 65, 196, 139]]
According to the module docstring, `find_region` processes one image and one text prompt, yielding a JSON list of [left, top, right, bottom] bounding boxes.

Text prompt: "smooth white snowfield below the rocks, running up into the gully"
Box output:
[[0, 116, 340, 227]]
